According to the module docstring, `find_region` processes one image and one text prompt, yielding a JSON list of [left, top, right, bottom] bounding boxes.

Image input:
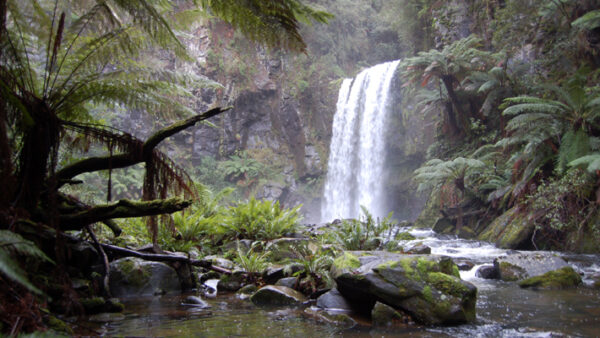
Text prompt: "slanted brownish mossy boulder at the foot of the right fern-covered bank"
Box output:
[[477, 207, 535, 249]]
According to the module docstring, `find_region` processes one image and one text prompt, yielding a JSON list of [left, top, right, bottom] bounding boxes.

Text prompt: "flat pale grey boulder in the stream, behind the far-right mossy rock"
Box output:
[[494, 252, 569, 281]]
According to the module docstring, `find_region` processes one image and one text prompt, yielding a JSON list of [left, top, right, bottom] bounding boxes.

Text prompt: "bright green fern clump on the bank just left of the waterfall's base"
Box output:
[[220, 197, 300, 240]]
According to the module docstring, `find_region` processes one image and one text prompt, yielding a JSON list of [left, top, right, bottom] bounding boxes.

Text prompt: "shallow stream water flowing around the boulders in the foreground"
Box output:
[[81, 230, 600, 337]]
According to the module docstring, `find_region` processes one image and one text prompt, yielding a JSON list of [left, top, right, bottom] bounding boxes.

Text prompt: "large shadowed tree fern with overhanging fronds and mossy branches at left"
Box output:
[[0, 0, 329, 333]]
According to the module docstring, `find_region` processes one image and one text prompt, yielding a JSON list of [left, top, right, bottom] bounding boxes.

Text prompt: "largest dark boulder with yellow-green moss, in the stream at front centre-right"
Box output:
[[331, 251, 477, 325]]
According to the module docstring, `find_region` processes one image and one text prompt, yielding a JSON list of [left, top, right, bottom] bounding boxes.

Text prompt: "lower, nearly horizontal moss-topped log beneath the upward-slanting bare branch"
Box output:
[[60, 197, 192, 228]]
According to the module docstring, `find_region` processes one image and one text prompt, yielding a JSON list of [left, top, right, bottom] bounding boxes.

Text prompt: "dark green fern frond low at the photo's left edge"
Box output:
[[0, 230, 53, 294]]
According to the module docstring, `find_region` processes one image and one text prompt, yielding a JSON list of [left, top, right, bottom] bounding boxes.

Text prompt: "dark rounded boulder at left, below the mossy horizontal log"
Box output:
[[109, 257, 181, 297]]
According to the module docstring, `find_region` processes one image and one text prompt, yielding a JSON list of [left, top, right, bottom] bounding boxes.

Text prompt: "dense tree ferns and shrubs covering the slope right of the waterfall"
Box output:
[[402, 0, 600, 252]]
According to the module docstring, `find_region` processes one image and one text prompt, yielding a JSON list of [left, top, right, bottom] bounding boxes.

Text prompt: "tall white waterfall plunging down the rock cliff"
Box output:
[[321, 61, 400, 222]]
